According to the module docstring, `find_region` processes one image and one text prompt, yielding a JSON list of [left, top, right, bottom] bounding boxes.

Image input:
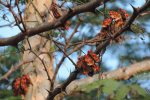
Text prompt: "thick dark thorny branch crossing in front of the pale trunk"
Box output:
[[0, 0, 109, 46]]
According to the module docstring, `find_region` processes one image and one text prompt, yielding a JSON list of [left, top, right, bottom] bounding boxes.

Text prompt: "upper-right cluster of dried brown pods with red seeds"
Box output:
[[98, 8, 129, 42]]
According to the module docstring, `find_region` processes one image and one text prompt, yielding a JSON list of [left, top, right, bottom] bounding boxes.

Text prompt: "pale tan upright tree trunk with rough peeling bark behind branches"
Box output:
[[23, 0, 53, 100]]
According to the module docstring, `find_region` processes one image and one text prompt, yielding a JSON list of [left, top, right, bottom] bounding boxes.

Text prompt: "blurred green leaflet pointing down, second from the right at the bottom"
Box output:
[[114, 84, 130, 100]]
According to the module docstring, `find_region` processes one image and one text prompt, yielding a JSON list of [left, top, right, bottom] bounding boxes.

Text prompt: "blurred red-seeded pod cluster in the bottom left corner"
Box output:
[[12, 74, 31, 96]]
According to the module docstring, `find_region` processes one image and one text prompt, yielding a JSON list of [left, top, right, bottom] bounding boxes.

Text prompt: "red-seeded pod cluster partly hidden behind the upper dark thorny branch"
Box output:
[[50, 3, 70, 30]]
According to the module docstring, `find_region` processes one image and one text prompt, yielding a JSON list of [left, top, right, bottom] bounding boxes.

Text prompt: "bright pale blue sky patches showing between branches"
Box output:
[[0, 0, 149, 79]]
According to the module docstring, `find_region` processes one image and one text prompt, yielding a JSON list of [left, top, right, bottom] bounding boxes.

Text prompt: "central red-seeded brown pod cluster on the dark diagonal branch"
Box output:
[[77, 50, 99, 77]]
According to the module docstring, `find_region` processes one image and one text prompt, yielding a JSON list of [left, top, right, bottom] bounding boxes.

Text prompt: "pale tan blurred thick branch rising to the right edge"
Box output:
[[54, 60, 150, 100]]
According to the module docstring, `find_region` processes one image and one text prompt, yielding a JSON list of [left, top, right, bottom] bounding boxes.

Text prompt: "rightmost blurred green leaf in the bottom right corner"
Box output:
[[129, 85, 146, 97]]
